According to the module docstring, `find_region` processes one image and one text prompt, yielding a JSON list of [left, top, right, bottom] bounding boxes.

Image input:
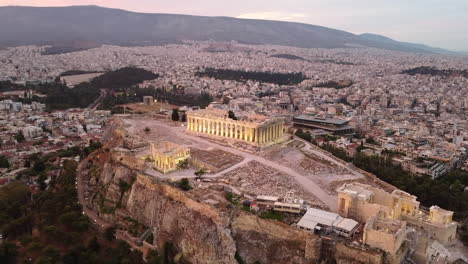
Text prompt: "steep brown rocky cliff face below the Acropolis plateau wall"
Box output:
[[81, 148, 320, 264]]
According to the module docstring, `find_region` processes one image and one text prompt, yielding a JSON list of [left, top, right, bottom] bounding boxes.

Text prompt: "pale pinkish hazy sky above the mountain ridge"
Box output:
[[0, 0, 468, 51]]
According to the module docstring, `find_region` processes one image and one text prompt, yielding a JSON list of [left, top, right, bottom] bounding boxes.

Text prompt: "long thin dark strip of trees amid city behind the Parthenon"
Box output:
[[195, 68, 307, 85]]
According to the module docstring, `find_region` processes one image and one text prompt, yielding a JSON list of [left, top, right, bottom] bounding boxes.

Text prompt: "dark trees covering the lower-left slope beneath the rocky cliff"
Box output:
[[0, 143, 163, 264]]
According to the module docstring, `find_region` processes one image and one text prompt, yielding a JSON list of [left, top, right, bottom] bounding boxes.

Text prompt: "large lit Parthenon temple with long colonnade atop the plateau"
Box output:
[[187, 108, 284, 146]]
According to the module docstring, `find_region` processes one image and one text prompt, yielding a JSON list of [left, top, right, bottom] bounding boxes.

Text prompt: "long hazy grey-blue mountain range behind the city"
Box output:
[[0, 6, 453, 54]]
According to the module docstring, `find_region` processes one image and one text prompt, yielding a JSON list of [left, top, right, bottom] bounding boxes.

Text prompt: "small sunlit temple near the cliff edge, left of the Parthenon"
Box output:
[[151, 141, 190, 173]]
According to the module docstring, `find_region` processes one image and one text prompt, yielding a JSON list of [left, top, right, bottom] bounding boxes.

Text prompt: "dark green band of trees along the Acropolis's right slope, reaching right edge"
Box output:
[[323, 144, 468, 219]]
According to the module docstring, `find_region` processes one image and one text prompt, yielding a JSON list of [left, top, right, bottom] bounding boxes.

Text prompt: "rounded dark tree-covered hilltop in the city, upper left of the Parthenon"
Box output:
[[91, 67, 159, 89]]
